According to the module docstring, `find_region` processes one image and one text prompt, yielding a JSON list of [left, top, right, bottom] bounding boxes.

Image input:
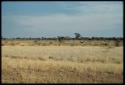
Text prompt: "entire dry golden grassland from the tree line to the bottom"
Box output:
[[1, 40, 123, 83]]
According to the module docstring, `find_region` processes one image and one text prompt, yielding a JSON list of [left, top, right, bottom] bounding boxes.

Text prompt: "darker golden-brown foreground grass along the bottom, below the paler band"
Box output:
[[2, 58, 123, 83]]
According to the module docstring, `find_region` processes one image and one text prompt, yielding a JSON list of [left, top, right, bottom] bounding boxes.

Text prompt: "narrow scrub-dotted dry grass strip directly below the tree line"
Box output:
[[2, 40, 123, 46]]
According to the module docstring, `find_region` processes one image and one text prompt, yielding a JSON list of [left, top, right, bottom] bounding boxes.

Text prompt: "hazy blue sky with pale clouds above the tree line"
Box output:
[[1, 1, 123, 38]]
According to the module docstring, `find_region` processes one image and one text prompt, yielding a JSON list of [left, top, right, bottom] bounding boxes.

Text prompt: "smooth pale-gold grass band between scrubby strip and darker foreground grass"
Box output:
[[2, 46, 123, 63]]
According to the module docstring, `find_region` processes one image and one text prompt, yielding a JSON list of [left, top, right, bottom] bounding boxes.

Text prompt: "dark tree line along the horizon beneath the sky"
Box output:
[[2, 33, 123, 42]]
